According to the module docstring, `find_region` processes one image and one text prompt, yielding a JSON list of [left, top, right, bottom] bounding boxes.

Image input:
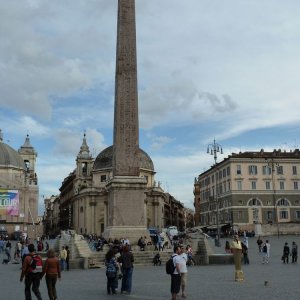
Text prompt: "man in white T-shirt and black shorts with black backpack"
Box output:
[[166, 244, 181, 300]]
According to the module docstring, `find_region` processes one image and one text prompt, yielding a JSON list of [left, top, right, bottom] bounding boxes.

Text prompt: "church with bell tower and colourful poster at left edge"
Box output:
[[0, 130, 39, 237]]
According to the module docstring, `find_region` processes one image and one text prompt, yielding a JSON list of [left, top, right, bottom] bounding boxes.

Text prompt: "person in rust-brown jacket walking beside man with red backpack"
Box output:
[[41, 249, 61, 300]]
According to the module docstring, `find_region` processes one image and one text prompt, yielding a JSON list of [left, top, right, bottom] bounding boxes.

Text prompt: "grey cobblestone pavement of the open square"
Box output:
[[0, 236, 300, 300]]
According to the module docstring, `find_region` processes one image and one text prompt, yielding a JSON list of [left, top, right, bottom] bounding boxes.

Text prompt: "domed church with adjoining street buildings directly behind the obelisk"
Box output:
[[44, 135, 193, 235]]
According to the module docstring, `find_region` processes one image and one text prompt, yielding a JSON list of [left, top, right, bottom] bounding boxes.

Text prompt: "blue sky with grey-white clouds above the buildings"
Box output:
[[0, 0, 300, 212]]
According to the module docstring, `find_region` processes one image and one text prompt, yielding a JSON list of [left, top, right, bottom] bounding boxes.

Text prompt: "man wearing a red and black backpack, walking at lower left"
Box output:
[[20, 244, 43, 300]]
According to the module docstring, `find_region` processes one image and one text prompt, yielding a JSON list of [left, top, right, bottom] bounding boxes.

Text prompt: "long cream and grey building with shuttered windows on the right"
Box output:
[[194, 149, 300, 234]]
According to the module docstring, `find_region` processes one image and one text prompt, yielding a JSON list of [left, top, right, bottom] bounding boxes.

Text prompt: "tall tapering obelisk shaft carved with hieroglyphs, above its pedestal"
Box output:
[[113, 0, 139, 176]]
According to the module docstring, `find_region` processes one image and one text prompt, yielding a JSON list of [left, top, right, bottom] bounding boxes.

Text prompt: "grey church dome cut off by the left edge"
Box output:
[[0, 141, 24, 169]]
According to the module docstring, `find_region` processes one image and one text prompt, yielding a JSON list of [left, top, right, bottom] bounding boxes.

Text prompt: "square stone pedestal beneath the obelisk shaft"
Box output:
[[103, 176, 149, 244]]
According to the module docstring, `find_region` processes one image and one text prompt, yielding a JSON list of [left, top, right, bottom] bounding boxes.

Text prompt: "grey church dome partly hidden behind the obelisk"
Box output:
[[93, 146, 154, 171]]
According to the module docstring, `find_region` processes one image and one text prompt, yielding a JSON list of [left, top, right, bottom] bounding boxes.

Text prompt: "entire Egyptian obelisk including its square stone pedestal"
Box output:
[[103, 0, 147, 243]]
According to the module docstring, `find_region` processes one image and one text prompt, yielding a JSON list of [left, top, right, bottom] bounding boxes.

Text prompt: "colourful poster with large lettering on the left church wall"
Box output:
[[0, 189, 19, 216]]
